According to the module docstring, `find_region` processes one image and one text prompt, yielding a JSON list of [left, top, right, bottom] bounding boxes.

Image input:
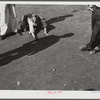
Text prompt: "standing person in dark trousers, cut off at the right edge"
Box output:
[[79, 5, 100, 54]]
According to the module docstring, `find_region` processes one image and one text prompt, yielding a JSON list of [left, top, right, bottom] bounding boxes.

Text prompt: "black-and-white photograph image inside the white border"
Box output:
[[0, 2, 100, 93]]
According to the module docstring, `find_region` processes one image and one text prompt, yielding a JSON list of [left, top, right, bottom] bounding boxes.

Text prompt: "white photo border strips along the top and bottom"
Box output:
[[0, 1, 100, 99]]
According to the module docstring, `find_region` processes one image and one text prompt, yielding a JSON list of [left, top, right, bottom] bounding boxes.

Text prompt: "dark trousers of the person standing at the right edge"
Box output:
[[87, 6, 100, 49]]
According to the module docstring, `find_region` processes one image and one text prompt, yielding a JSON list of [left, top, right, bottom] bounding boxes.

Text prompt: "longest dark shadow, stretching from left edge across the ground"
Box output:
[[0, 33, 74, 66]]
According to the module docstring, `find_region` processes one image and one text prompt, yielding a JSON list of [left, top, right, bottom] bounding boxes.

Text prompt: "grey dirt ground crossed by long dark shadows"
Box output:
[[0, 5, 100, 90]]
